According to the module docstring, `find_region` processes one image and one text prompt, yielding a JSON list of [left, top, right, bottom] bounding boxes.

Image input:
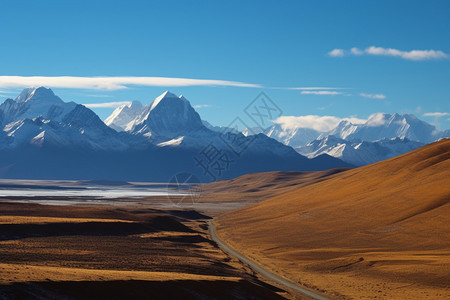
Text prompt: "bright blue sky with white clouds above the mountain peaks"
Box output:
[[0, 0, 450, 129]]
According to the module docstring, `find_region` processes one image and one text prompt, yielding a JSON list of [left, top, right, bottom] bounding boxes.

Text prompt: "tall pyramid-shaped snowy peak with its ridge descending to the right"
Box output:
[[105, 91, 342, 162]]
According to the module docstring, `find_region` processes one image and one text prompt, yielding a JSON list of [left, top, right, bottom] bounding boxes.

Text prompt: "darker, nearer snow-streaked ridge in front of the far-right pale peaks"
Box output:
[[296, 135, 424, 166]]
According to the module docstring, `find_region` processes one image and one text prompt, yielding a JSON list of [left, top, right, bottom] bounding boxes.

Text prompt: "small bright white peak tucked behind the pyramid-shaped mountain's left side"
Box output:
[[105, 101, 143, 131]]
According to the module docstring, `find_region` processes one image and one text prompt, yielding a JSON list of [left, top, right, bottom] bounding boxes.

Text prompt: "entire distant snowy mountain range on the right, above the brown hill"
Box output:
[[239, 113, 450, 166]]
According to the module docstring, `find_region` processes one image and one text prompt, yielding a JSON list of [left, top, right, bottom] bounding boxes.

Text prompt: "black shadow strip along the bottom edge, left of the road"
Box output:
[[0, 280, 284, 299]]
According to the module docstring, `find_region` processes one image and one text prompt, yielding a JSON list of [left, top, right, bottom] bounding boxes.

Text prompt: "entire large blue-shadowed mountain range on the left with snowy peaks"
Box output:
[[0, 87, 351, 182]]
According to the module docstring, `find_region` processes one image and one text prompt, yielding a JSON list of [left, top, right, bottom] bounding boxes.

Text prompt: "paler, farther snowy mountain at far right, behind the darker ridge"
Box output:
[[322, 113, 448, 143]]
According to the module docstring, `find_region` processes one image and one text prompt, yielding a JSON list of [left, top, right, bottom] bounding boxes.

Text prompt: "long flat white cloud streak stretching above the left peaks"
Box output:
[[0, 76, 262, 91]]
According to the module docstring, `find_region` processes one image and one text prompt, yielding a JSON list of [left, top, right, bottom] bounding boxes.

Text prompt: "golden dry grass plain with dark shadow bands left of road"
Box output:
[[0, 202, 285, 299]]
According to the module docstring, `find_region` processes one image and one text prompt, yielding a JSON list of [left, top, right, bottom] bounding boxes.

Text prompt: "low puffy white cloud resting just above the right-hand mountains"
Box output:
[[273, 115, 366, 132]]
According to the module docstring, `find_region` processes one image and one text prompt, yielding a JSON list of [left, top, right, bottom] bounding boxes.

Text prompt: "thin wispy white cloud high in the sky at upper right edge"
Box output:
[[328, 46, 449, 61]]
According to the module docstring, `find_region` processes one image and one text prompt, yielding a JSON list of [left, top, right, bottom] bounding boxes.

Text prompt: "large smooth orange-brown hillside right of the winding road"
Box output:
[[216, 139, 450, 299]]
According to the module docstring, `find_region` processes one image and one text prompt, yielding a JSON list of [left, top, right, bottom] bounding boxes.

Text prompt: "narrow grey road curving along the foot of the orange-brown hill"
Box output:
[[208, 221, 328, 300]]
